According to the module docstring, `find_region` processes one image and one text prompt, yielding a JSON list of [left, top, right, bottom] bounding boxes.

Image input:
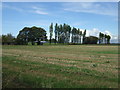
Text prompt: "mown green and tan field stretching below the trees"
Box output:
[[2, 45, 119, 88]]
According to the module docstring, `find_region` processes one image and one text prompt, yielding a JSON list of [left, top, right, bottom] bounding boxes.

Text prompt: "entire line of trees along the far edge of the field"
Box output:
[[2, 23, 111, 45]]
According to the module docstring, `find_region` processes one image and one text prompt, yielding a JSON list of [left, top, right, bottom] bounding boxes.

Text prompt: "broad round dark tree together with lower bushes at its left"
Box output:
[[2, 26, 47, 45]]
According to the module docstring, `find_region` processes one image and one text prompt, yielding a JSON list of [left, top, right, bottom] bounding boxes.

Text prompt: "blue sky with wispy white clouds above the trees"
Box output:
[[2, 2, 118, 42]]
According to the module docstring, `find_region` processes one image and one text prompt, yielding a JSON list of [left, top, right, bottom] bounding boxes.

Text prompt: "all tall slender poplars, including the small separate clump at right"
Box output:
[[49, 23, 111, 44]]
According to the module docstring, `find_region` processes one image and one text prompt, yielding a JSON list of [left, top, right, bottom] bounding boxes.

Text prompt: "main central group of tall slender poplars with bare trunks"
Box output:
[[49, 23, 86, 44]]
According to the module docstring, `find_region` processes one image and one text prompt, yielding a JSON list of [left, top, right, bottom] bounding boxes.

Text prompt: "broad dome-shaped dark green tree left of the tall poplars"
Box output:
[[17, 26, 47, 45]]
